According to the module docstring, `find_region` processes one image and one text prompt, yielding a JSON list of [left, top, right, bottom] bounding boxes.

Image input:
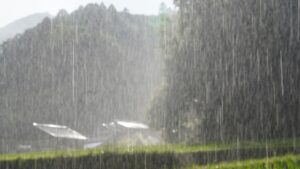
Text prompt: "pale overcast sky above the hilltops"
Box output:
[[0, 0, 173, 27]]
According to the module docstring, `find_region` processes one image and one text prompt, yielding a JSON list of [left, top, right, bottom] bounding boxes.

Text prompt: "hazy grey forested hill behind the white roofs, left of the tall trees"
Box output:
[[0, 4, 162, 145]]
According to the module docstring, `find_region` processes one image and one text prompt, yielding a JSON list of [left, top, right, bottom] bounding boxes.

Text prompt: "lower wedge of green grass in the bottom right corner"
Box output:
[[187, 155, 300, 169]]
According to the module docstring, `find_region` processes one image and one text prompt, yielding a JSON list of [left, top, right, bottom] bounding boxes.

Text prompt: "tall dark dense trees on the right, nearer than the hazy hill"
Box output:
[[149, 0, 300, 143]]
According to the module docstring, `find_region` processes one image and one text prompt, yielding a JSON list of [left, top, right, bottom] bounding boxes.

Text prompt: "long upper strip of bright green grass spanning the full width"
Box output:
[[0, 138, 300, 161]]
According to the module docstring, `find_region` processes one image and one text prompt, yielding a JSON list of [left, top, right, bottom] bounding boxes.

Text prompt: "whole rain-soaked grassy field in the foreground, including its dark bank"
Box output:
[[0, 139, 300, 169]]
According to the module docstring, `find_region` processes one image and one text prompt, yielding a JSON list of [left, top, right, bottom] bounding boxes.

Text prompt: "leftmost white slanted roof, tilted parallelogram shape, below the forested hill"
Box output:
[[33, 123, 87, 140]]
